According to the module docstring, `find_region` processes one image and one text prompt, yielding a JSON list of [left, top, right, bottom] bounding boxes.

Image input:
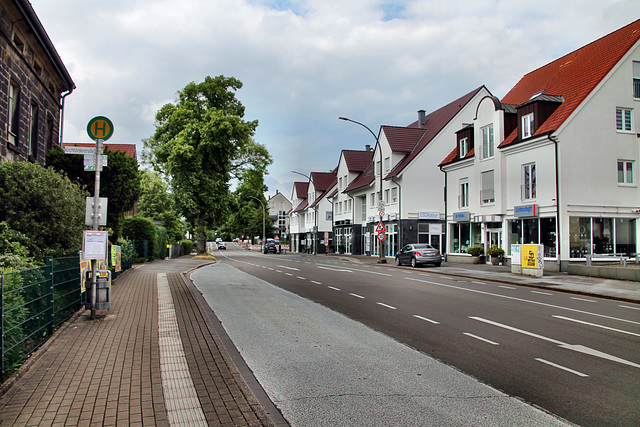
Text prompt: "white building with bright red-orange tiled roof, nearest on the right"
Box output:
[[440, 20, 640, 270]]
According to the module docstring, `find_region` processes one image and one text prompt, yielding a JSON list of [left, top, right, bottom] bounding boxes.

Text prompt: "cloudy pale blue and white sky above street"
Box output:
[[31, 0, 640, 197]]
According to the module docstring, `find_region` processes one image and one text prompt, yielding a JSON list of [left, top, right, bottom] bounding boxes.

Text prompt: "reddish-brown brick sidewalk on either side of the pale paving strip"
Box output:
[[0, 261, 282, 426]]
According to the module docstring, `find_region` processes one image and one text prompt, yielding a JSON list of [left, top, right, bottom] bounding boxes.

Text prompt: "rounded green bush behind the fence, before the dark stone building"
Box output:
[[0, 162, 86, 262]]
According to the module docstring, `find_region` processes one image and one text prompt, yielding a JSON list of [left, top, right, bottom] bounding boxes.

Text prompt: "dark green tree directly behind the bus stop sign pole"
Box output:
[[46, 147, 141, 242]]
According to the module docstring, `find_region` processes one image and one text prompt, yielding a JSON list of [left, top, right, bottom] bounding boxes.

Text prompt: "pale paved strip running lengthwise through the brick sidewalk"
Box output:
[[156, 273, 207, 426]]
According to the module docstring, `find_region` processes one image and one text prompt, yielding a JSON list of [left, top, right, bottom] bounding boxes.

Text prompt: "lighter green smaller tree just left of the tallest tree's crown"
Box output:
[[138, 170, 184, 242]]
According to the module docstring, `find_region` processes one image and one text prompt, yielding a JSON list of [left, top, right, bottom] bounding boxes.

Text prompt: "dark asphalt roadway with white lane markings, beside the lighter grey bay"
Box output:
[[194, 245, 640, 425]]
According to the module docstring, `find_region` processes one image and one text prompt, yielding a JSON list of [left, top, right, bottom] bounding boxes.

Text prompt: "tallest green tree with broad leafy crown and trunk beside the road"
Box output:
[[145, 76, 271, 253]]
